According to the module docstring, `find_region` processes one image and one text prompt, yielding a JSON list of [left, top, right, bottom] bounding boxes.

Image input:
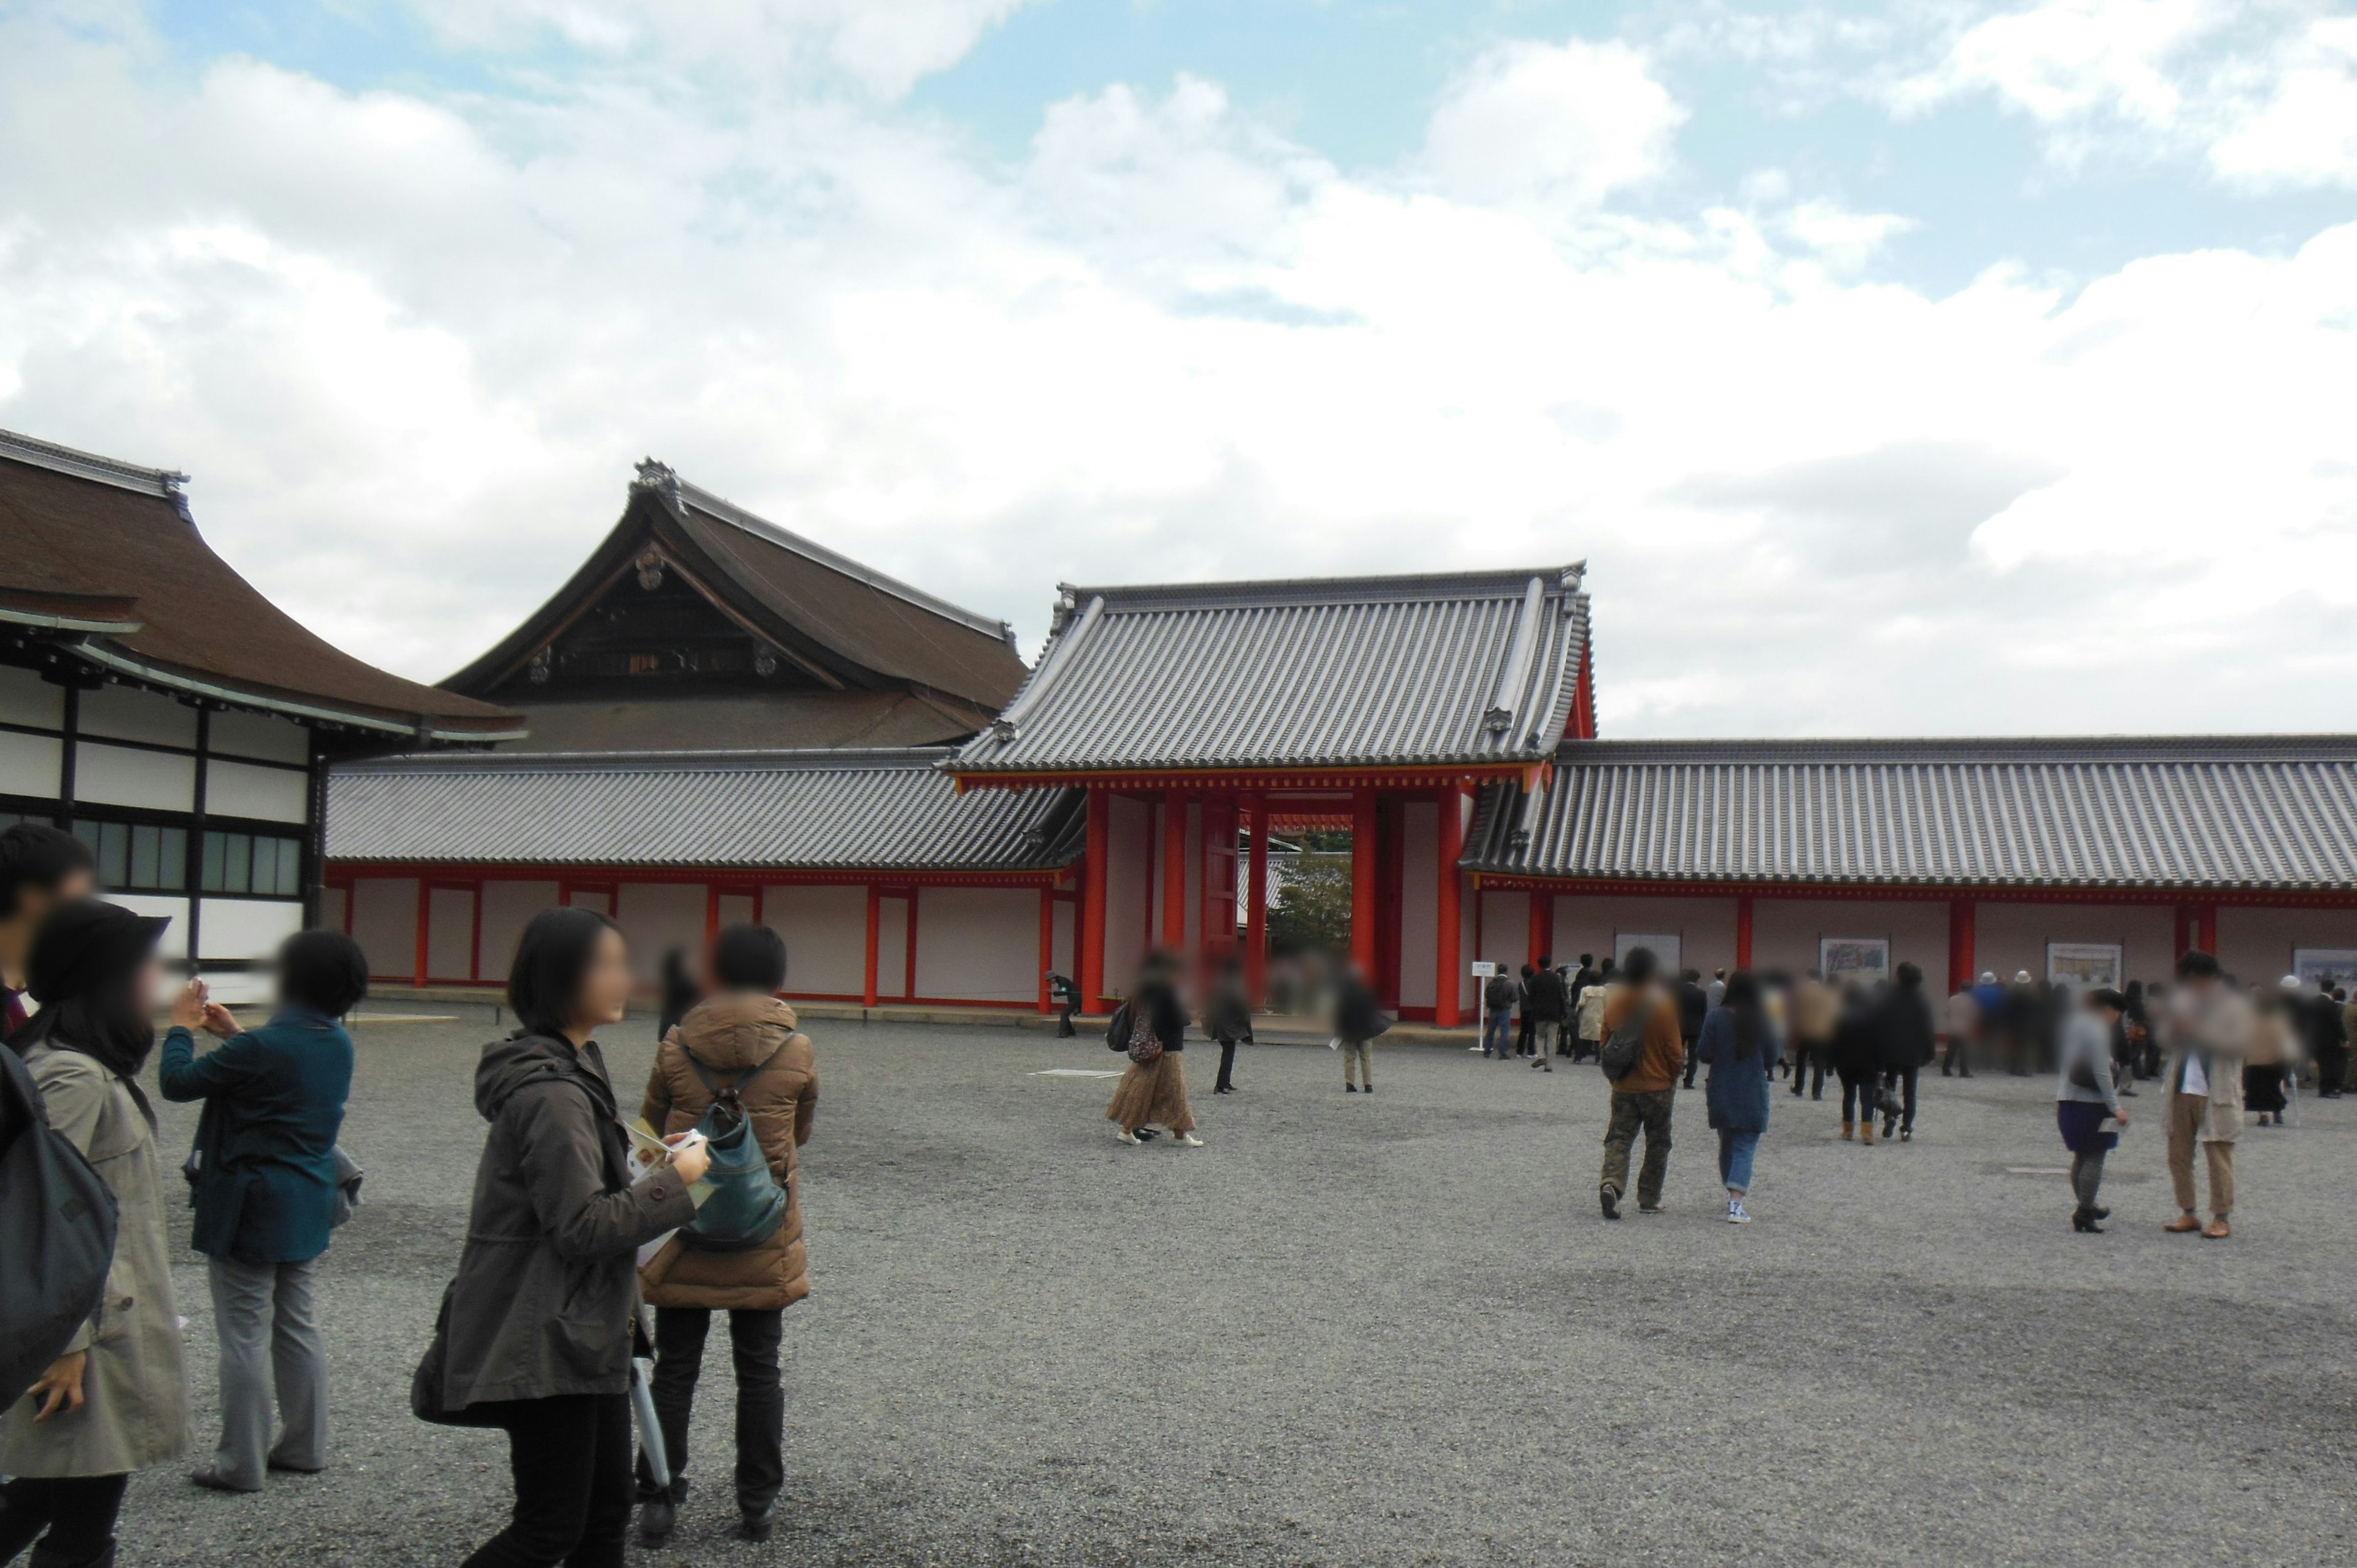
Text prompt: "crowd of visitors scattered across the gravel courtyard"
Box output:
[[0, 806, 2357, 1568]]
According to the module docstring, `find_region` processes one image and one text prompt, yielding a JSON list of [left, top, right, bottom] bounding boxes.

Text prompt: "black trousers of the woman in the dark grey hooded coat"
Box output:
[[466, 1394, 629, 1568]]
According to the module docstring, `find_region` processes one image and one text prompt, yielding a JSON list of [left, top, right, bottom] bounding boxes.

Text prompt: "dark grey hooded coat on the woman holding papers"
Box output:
[[441, 1035, 695, 1410]]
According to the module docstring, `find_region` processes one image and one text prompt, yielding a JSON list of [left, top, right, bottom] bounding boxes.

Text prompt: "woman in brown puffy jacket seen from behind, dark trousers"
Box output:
[[639, 927, 818, 1545]]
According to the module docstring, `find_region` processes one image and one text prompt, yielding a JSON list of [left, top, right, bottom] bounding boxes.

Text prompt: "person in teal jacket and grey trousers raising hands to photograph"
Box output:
[[155, 932, 368, 1493]]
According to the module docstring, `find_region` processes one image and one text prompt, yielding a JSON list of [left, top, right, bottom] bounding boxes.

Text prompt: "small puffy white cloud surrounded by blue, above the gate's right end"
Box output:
[[1423, 37, 1686, 207]]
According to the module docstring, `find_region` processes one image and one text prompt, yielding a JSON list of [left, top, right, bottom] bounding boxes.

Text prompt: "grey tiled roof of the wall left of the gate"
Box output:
[[328, 747, 1084, 870]]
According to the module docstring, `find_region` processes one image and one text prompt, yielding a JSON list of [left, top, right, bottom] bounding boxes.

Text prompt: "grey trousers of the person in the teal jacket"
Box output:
[[205, 1257, 328, 1488]]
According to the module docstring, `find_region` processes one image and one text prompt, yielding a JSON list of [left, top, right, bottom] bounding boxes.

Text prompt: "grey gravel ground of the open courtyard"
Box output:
[[106, 1014, 2357, 1566]]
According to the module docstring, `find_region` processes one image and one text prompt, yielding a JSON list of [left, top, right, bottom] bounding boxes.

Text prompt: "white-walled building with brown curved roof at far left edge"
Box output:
[[0, 431, 523, 1000]]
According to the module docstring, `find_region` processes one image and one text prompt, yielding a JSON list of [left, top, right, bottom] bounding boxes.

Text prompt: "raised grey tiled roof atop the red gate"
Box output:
[[950, 566, 1589, 778]]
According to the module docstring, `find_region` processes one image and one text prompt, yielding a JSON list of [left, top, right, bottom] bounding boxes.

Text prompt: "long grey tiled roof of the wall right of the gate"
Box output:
[[1464, 736, 2357, 891]]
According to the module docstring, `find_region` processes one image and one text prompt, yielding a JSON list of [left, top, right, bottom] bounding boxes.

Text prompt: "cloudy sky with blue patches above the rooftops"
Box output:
[[0, 0, 2357, 736]]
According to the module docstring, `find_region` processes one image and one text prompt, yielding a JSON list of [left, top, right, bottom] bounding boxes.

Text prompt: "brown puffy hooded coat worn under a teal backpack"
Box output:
[[639, 993, 818, 1311]]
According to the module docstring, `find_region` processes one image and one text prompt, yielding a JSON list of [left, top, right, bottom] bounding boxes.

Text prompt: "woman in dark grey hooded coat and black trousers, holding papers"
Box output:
[[436, 905, 712, 1568]]
